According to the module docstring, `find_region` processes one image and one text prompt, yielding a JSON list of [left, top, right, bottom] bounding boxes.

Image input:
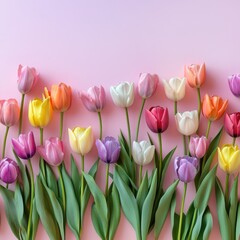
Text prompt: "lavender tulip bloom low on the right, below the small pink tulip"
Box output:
[[174, 156, 199, 183]]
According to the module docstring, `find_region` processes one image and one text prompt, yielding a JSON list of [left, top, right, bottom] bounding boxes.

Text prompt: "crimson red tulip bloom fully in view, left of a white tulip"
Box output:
[[145, 106, 169, 133]]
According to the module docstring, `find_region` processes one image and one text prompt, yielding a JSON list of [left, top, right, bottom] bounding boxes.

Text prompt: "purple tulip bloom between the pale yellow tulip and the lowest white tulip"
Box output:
[[96, 137, 121, 163]]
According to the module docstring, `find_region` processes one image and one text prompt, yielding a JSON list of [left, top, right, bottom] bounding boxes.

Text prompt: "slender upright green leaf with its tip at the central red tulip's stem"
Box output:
[[141, 170, 157, 239]]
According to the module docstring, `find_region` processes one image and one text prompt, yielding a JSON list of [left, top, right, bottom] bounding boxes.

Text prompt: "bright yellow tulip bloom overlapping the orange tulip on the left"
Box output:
[[28, 97, 52, 128]]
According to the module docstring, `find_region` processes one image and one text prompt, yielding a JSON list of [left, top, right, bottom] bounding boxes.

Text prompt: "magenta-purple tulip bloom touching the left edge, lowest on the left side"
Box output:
[[0, 158, 19, 184]]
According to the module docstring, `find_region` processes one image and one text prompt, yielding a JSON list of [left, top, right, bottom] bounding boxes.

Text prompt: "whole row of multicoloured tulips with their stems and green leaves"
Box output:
[[0, 64, 240, 240]]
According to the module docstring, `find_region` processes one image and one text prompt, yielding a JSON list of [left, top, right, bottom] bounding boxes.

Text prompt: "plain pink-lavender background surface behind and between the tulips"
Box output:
[[0, 0, 240, 239]]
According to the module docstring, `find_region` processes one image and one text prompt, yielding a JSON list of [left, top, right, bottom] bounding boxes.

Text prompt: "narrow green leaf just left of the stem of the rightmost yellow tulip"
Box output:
[[215, 178, 232, 240]]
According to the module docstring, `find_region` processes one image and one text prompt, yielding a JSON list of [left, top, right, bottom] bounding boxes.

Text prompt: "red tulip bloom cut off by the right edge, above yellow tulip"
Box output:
[[224, 112, 240, 138]]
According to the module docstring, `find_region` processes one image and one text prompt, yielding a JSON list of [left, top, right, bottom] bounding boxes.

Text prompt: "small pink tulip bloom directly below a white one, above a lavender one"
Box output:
[[189, 136, 210, 159]]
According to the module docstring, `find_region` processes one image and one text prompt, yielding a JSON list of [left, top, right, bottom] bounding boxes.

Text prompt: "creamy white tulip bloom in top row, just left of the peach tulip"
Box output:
[[163, 78, 186, 101]]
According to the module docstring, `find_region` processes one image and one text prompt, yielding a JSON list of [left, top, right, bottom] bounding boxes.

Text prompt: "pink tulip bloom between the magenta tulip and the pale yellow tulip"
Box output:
[[37, 137, 64, 166]]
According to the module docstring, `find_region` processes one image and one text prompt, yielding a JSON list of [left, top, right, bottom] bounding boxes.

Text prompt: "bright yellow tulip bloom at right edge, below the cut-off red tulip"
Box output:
[[218, 145, 240, 173]]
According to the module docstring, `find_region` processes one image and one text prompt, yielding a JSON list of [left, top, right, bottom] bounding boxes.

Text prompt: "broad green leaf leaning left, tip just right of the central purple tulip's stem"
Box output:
[[113, 167, 141, 239]]
